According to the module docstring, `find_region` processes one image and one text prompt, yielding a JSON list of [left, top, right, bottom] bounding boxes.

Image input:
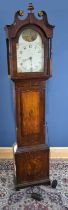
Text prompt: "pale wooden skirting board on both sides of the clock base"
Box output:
[[0, 147, 68, 159]]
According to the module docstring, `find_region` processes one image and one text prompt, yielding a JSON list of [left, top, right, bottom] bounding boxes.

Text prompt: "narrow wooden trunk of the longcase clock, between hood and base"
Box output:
[[15, 80, 45, 147]]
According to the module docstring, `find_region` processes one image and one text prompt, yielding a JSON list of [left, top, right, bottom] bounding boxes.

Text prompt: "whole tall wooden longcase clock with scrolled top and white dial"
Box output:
[[5, 3, 54, 187]]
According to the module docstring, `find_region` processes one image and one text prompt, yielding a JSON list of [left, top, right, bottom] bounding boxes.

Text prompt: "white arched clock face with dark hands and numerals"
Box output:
[[16, 28, 44, 73]]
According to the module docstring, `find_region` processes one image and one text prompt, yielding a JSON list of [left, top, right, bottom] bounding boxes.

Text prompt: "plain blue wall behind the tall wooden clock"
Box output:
[[0, 0, 68, 146]]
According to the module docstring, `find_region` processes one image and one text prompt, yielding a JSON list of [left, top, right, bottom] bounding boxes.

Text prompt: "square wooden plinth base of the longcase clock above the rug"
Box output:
[[14, 144, 50, 188]]
